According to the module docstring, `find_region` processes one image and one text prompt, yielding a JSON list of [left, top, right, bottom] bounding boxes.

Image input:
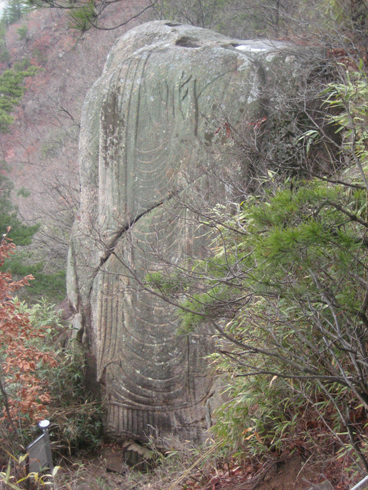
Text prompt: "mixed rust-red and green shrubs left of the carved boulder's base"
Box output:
[[0, 236, 103, 481]]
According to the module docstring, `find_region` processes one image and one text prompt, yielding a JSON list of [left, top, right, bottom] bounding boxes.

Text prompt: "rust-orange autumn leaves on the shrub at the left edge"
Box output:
[[0, 236, 57, 420]]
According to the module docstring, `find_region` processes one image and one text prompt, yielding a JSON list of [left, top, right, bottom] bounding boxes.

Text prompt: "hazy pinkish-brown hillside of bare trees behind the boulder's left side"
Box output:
[[1, 2, 150, 300]]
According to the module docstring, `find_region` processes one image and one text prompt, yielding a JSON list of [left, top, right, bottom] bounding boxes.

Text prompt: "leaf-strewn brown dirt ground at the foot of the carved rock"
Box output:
[[55, 455, 356, 490]]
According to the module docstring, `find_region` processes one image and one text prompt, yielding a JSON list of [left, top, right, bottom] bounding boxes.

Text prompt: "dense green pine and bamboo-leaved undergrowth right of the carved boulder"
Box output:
[[170, 63, 368, 477]]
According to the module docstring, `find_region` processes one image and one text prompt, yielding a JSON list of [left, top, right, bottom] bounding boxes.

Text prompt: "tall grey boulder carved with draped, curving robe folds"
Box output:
[[68, 21, 314, 440]]
